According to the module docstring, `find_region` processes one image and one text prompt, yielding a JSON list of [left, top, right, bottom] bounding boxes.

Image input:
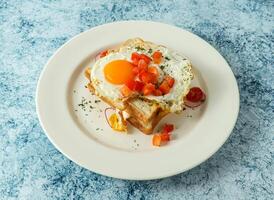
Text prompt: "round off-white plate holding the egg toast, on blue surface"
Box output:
[[36, 21, 239, 180]]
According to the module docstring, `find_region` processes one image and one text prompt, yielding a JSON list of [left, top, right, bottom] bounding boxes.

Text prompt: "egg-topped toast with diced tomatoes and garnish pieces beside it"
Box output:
[[85, 38, 205, 138]]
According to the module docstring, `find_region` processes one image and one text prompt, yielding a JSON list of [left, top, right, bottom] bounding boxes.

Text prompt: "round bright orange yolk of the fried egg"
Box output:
[[104, 60, 134, 84]]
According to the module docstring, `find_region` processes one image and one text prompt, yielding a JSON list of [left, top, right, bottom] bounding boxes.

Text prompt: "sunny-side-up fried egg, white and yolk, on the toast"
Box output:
[[90, 46, 193, 112]]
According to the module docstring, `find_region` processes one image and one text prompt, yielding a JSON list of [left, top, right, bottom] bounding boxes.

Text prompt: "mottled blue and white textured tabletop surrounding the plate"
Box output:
[[0, 0, 274, 199]]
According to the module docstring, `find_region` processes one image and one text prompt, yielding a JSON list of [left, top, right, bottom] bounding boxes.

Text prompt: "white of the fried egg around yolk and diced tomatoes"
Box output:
[[90, 46, 193, 112]]
